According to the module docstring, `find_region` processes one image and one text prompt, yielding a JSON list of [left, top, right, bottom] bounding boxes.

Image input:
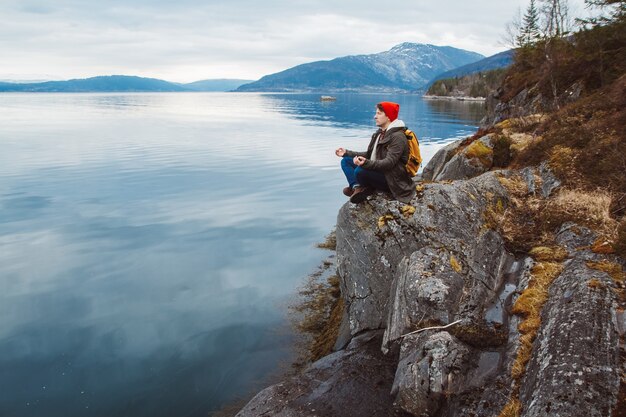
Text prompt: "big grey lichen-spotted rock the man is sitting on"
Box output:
[[337, 173, 508, 341]]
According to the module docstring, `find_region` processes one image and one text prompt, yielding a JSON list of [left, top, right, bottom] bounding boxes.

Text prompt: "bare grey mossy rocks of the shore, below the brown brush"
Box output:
[[237, 126, 626, 417]]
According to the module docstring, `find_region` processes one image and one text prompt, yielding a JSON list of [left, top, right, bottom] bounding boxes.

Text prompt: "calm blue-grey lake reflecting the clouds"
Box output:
[[0, 93, 483, 417]]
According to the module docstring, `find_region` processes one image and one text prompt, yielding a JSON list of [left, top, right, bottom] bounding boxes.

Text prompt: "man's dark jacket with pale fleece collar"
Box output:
[[346, 120, 415, 203]]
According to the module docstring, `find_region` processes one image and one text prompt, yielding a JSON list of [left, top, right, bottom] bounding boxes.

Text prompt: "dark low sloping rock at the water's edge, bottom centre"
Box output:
[[236, 332, 409, 417]]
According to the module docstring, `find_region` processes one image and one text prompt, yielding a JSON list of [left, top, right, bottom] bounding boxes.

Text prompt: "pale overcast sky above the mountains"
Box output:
[[0, 0, 584, 82]]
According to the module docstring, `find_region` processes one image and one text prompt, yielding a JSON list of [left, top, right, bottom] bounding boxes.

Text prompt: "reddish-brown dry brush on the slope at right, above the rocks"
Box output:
[[512, 75, 626, 219]]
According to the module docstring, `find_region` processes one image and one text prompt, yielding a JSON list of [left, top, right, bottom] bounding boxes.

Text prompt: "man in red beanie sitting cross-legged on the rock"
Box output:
[[335, 101, 415, 204]]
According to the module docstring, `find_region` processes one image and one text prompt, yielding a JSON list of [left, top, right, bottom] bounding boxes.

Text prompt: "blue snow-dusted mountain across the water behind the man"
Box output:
[[236, 42, 484, 91]]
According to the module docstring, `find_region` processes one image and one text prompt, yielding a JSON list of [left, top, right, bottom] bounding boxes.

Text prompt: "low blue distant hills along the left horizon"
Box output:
[[0, 75, 254, 93]]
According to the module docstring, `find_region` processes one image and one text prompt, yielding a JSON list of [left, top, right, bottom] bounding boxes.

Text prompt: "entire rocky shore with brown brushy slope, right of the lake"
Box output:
[[233, 20, 626, 417]]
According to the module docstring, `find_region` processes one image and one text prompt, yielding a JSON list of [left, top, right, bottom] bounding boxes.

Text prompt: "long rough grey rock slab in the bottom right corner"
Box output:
[[520, 225, 621, 417]]
